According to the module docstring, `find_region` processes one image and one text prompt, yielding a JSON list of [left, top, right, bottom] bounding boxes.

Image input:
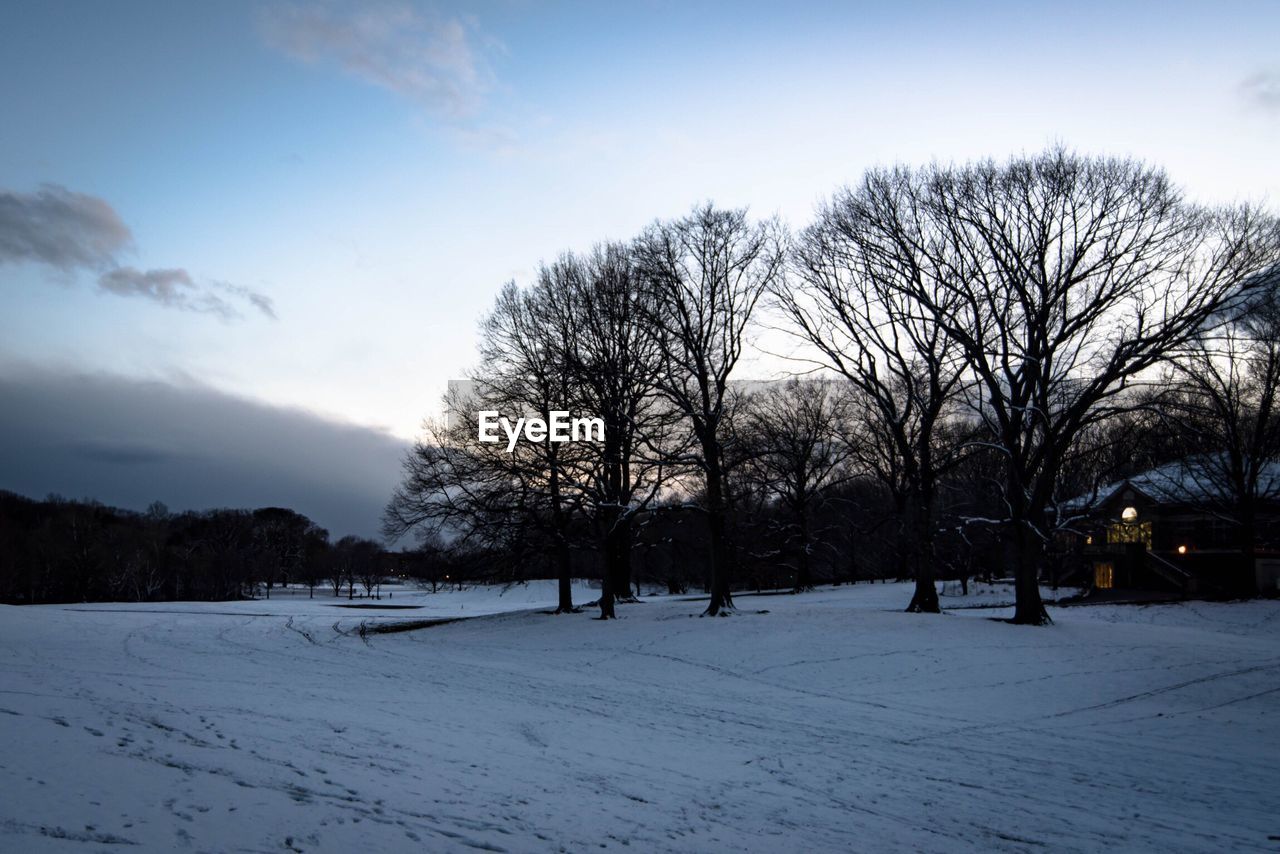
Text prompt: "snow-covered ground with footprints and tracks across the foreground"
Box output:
[[0, 585, 1280, 851]]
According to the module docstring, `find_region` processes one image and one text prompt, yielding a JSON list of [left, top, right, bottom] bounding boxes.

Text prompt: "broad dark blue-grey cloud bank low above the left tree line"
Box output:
[[0, 362, 406, 539]]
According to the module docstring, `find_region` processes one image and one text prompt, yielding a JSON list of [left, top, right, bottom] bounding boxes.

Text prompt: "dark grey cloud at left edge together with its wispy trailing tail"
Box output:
[[0, 184, 275, 320]]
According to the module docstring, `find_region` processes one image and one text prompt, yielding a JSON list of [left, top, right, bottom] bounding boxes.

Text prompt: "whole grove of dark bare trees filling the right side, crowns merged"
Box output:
[[384, 149, 1280, 624]]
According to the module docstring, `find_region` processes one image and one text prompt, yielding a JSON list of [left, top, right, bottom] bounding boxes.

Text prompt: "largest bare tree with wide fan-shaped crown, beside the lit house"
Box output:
[[890, 149, 1277, 625]]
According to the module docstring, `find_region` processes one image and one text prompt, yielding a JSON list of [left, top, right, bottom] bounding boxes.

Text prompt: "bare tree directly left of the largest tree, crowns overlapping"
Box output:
[[776, 184, 968, 613]]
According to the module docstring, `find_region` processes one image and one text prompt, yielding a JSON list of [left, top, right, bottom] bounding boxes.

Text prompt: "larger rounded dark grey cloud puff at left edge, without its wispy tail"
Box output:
[[0, 184, 133, 271]]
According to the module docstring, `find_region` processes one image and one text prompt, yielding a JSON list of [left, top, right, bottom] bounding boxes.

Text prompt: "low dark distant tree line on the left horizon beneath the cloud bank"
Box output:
[[0, 490, 449, 604]]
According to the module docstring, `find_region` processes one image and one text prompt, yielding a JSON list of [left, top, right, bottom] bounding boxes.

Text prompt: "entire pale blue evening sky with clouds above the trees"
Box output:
[[0, 0, 1280, 534]]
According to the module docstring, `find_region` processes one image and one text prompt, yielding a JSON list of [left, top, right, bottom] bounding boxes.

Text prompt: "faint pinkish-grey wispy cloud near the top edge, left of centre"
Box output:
[[260, 4, 490, 119]]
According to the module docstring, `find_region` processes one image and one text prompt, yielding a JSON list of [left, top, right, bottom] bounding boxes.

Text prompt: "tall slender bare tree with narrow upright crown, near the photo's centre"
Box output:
[[635, 204, 782, 616]]
